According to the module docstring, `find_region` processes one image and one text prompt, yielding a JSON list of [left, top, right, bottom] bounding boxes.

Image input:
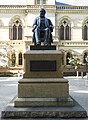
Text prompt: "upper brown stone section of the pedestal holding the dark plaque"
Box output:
[[23, 50, 63, 78]]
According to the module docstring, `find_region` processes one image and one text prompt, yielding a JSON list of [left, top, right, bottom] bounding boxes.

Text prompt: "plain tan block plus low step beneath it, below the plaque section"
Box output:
[[15, 78, 74, 107]]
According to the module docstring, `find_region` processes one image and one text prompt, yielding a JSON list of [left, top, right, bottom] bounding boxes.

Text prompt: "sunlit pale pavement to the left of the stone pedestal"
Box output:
[[0, 77, 20, 117]]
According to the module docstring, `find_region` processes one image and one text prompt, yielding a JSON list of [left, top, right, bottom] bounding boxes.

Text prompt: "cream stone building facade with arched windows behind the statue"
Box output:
[[0, 0, 88, 72]]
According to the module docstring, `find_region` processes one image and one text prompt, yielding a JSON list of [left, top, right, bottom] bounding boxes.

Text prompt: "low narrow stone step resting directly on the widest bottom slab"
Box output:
[[15, 97, 74, 107]]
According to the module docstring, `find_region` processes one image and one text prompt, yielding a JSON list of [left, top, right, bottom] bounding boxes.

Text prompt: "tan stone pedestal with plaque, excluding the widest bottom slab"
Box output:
[[14, 50, 73, 107]]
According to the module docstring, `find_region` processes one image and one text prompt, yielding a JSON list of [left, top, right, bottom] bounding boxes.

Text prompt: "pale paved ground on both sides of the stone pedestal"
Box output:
[[0, 77, 88, 120]]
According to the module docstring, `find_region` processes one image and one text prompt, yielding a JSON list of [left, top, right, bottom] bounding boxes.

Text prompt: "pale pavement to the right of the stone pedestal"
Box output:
[[66, 77, 88, 114]]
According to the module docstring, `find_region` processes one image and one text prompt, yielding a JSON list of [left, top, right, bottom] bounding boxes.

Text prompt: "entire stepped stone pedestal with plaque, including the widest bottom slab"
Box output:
[[1, 46, 87, 119]]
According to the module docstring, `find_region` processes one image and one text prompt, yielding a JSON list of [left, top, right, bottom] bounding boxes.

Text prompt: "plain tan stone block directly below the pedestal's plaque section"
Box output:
[[18, 78, 69, 99]]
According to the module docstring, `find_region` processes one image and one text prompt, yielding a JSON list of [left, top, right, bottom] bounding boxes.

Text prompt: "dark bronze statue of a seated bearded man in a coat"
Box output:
[[32, 8, 54, 46]]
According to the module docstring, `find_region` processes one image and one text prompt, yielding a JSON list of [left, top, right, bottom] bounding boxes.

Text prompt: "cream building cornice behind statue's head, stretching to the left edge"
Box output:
[[0, 5, 56, 14]]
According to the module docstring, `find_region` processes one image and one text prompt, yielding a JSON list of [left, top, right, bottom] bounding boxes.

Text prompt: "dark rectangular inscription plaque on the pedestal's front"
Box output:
[[30, 60, 56, 71]]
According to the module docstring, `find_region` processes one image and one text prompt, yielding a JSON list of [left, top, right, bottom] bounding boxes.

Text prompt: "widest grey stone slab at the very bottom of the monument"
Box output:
[[1, 99, 87, 120]]
